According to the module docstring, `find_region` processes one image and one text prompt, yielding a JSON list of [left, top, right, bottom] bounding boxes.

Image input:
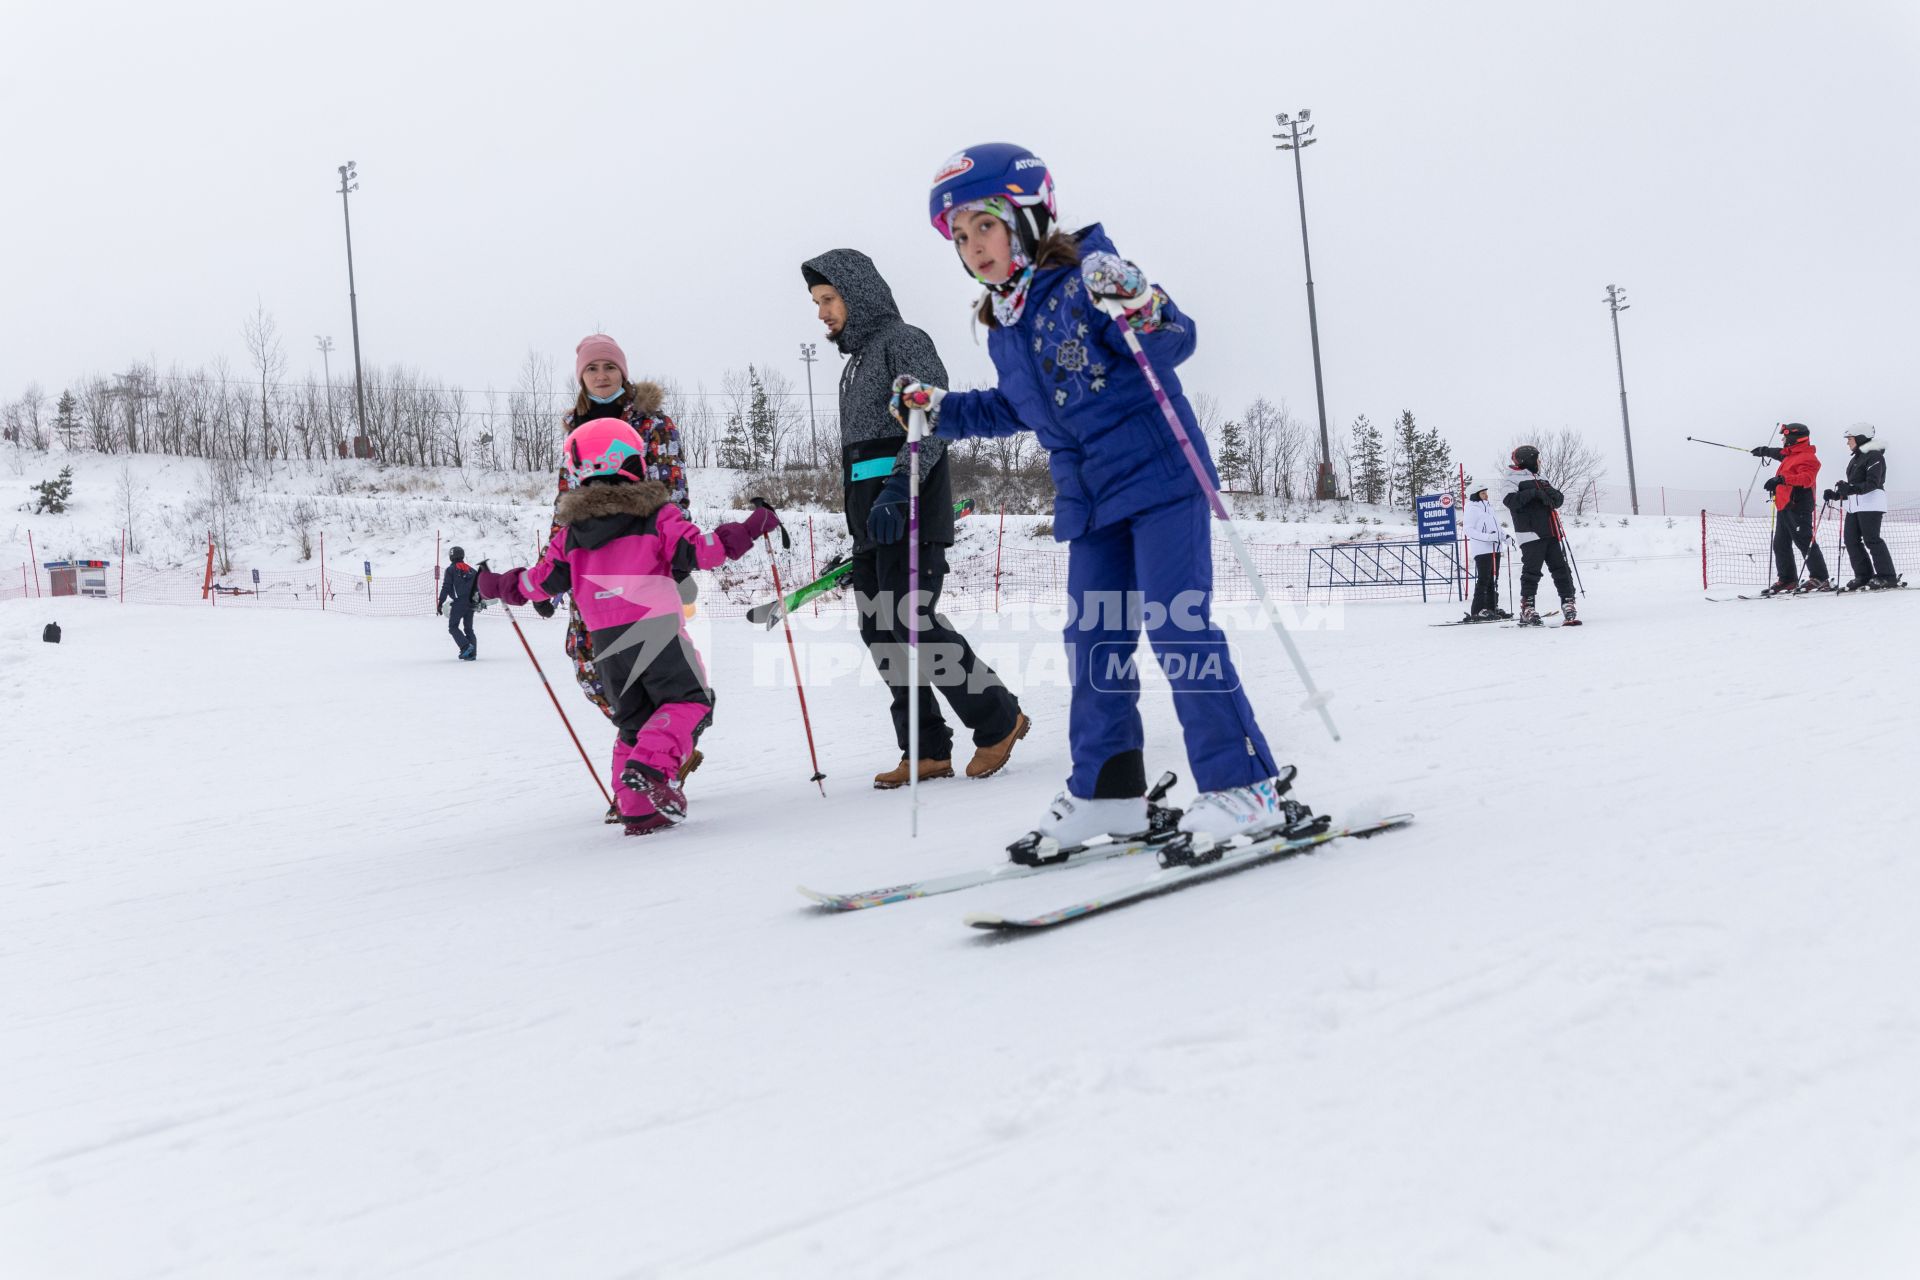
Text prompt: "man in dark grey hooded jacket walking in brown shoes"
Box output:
[[801, 249, 1027, 791]]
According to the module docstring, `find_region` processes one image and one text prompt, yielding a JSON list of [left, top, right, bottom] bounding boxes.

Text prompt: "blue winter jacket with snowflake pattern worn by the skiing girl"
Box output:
[[935, 223, 1219, 541]]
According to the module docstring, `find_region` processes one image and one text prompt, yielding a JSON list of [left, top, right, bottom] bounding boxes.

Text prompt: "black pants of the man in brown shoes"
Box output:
[[849, 541, 1020, 760]]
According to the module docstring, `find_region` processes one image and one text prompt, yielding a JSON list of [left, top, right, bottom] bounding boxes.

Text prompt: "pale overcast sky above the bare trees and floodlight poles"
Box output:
[[0, 0, 1920, 495]]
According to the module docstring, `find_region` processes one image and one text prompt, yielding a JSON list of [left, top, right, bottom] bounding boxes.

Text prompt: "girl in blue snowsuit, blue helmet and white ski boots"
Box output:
[[895, 142, 1292, 846]]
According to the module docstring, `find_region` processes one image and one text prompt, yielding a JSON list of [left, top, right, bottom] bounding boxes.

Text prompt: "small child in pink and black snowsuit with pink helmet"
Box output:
[[480, 418, 780, 835]]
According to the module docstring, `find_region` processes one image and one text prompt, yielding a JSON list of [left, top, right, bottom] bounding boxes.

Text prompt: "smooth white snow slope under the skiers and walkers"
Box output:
[[0, 560, 1920, 1280]]
